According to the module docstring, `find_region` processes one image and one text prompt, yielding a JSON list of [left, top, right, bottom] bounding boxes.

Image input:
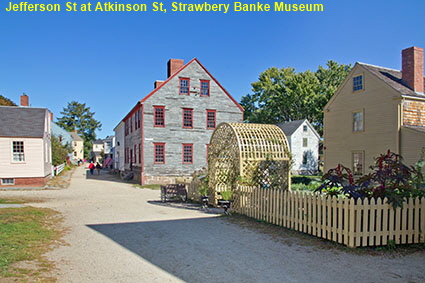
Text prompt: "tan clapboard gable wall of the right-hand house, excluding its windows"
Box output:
[[324, 65, 401, 173]]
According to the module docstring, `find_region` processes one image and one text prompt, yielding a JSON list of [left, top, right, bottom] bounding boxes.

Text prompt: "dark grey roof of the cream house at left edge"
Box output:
[[0, 106, 49, 138]]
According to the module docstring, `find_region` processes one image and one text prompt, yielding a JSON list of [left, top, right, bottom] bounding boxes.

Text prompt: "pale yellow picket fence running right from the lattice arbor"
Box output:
[[232, 187, 425, 247]]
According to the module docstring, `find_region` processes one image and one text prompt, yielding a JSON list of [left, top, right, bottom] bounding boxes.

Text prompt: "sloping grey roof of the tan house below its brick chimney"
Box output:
[[356, 62, 425, 98]]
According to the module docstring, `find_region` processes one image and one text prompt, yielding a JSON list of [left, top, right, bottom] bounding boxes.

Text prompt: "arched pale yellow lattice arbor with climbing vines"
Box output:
[[208, 123, 291, 205]]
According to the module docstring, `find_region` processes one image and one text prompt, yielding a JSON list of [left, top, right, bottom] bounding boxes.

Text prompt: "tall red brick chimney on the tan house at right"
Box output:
[[401, 46, 424, 93]]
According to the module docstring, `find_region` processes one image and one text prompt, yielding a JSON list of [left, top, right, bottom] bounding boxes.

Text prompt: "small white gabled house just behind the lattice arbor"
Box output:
[[277, 119, 320, 175]]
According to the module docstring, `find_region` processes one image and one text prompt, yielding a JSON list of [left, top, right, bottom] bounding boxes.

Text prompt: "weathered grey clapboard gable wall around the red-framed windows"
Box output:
[[143, 61, 242, 179]]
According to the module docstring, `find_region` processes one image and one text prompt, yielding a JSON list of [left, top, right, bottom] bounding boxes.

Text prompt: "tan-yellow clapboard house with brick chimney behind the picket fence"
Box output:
[[324, 47, 425, 175]]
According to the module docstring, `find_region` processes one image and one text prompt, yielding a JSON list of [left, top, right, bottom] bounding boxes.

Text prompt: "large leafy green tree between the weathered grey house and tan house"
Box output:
[[241, 60, 351, 133]]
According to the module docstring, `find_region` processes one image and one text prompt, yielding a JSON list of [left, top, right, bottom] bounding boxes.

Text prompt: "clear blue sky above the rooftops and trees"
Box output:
[[0, 0, 425, 138]]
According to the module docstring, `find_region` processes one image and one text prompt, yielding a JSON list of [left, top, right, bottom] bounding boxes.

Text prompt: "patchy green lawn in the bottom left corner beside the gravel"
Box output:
[[0, 204, 61, 282]]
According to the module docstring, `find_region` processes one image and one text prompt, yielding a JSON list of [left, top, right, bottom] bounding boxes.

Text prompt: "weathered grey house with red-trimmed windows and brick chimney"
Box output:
[[117, 58, 243, 184]]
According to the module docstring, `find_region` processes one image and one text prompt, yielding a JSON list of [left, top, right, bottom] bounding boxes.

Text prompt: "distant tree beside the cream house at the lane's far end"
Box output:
[[57, 101, 102, 157]]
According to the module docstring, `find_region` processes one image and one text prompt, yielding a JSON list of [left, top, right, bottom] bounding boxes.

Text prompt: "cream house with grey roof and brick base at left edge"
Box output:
[[0, 95, 52, 188]]
